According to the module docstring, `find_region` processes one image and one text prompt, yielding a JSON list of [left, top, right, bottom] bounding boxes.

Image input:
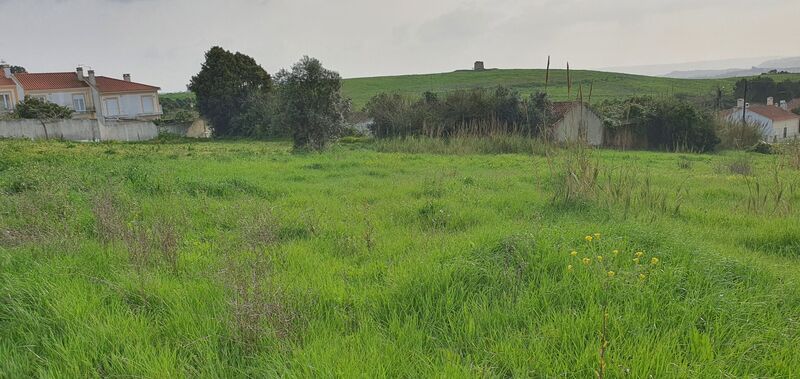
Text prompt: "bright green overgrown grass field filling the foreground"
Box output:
[[0, 139, 800, 378]]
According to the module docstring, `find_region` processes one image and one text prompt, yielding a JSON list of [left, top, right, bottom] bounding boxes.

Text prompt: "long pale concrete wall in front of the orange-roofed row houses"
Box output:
[[0, 119, 158, 142]]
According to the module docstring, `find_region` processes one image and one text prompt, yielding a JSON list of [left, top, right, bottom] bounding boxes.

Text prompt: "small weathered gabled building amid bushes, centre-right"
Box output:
[[550, 101, 605, 146]]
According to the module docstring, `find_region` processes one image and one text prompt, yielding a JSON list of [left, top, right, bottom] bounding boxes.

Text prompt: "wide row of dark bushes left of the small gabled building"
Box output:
[[365, 86, 553, 138]]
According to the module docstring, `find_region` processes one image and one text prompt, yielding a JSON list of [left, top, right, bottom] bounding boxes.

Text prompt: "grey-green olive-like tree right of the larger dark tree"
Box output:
[[276, 56, 350, 150]]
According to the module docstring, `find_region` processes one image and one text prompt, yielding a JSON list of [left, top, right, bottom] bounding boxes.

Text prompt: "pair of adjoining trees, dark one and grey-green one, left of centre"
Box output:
[[189, 46, 350, 149]]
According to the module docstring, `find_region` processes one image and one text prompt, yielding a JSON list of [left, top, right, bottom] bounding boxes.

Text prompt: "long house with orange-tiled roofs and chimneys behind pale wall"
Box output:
[[0, 66, 161, 120]]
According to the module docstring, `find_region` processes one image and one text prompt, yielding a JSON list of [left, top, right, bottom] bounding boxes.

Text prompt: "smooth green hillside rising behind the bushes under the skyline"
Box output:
[[162, 69, 800, 110]]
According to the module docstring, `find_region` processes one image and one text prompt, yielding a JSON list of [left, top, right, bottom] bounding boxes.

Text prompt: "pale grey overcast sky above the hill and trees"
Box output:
[[0, 0, 800, 92]]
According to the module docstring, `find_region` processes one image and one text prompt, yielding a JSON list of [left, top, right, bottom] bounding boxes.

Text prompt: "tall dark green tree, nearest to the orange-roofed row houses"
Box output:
[[189, 46, 272, 136]]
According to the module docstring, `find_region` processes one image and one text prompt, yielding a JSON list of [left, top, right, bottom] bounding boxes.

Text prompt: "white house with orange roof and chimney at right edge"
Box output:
[[724, 97, 800, 142]]
